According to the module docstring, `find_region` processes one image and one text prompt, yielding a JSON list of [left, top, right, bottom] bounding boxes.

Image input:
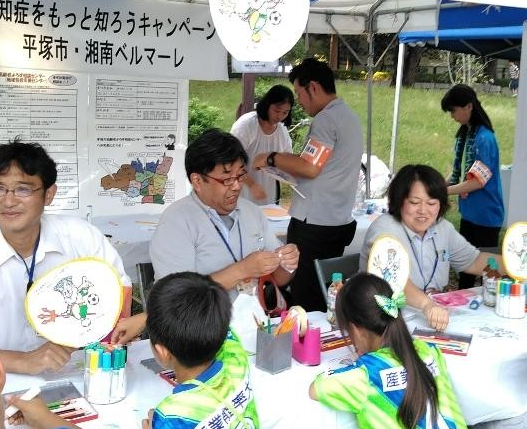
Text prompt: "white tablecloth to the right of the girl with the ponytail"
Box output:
[[408, 298, 527, 425]]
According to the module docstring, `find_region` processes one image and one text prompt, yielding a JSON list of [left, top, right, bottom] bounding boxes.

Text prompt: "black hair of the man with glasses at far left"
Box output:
[[0, 138, 57, 189]]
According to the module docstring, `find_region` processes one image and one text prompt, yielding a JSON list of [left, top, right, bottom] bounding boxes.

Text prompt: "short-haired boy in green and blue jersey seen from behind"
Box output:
[[143, 272, 259, 429]]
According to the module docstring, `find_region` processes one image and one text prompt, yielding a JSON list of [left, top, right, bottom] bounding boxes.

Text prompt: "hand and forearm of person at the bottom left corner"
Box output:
[[0, 361, 80, 429]]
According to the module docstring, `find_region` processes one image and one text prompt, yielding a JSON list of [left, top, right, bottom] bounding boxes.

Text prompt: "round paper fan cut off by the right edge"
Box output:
[[501, 222, 527, 281]]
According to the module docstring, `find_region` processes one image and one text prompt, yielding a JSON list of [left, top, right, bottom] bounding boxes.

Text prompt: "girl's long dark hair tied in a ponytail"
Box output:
[[335, 273, 438, 429]]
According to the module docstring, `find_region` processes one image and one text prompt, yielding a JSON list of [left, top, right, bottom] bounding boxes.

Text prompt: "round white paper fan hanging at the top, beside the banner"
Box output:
[[209, 0, 310, 61]]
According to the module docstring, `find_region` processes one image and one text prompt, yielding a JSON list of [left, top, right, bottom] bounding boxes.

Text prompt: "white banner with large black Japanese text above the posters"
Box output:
[[0, 0, 228, 80]]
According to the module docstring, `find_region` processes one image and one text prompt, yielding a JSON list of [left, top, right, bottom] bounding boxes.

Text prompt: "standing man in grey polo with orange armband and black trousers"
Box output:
[[253, 58, 363, 311]]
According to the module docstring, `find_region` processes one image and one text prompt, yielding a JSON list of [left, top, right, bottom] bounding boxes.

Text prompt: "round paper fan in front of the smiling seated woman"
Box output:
[[367, 235, 410, 292]]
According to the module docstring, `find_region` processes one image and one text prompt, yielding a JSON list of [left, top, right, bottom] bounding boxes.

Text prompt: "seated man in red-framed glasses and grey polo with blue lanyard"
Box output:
[[112, 129, 298, 342]]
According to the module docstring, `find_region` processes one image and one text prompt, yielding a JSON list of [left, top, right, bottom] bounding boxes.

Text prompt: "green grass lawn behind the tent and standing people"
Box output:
[[190, 79, 517, 229]]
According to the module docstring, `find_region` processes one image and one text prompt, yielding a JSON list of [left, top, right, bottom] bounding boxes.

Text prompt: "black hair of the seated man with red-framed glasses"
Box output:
[[185, 128, 249, 180]]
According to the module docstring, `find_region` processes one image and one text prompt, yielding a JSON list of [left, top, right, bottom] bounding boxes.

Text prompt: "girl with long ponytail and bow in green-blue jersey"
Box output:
[[309, 273, 467, 429]]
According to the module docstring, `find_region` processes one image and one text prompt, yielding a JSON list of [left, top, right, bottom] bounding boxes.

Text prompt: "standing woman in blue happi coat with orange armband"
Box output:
[[441, 84, 504, 289]]
